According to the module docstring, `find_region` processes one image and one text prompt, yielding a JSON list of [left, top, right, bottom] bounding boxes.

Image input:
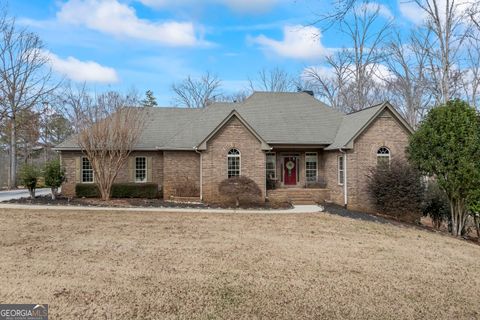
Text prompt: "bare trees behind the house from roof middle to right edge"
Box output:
[[173, 0, 480, 128]]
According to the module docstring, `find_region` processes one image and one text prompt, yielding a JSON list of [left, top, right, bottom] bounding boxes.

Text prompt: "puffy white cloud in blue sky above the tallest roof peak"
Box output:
[[250, 25, 329, 60]]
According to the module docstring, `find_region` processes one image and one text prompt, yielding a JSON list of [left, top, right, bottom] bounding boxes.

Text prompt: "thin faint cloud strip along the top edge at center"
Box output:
[[139, 0, 282, 13]]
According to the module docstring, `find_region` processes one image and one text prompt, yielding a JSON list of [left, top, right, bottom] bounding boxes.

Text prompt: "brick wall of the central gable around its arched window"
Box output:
[[202, 117, 265, 202]]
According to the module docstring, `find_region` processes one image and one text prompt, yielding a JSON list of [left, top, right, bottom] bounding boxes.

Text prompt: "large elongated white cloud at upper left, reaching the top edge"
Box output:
[[57, 0, 203, 46]]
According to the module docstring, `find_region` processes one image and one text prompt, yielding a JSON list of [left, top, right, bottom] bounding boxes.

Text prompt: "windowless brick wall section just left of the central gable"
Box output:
[[163, 151, 200, 199]]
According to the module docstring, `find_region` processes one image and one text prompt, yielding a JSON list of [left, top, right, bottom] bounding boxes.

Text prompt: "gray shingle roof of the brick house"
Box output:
[[56, 92, 408, 150]]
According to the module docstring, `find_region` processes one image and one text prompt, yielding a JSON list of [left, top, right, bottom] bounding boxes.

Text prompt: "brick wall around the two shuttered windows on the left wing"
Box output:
[[61, 151, 163, 197]]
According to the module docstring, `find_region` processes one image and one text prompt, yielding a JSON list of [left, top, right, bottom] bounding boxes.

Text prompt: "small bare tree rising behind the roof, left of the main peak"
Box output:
[[172, 72, 221, 108]]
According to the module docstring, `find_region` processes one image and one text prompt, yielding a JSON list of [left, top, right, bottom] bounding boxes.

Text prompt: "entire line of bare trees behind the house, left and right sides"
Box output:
[[0, 0, 480, 187]]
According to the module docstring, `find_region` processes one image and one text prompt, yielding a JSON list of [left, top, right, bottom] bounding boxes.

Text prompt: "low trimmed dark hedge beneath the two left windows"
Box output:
[[75, 183, 158, 199]]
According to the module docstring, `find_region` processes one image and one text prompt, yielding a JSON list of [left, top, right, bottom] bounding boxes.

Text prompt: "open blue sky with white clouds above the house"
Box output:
[[9, 0, 415, 105]]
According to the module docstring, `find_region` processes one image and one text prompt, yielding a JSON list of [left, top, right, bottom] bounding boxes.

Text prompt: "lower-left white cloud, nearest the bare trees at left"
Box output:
[[44, 51, 118, 83]]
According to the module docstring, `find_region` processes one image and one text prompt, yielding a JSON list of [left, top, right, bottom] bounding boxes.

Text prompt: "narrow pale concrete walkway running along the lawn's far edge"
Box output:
[[0, 203, 323, 213]]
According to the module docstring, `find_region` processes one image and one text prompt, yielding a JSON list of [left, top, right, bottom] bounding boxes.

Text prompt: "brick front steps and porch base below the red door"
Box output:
[[267, 188, 330, 205]]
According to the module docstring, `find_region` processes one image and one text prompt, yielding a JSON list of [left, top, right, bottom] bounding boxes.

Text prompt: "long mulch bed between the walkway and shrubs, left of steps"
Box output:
[[2, 195, 293, 210]]
